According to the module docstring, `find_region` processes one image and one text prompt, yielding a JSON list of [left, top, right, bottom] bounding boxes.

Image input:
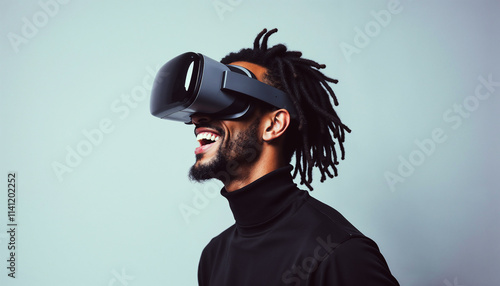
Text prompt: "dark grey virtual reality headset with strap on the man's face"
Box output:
[[150, 52, 297, 123]]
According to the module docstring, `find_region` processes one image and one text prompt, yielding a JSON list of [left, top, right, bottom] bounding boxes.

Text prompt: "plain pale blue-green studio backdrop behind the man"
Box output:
[[0, 0, 500, 286]]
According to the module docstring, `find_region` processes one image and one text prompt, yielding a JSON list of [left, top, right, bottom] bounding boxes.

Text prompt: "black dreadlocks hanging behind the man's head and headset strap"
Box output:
[[221, 29, 351, 191]]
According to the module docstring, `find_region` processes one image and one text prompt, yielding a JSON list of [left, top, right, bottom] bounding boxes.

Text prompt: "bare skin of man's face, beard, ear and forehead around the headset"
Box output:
[[189, 59, 290, 192]]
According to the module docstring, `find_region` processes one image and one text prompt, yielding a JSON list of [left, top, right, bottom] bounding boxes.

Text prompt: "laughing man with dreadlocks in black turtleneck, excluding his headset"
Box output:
[[152, 29, 399, 286]]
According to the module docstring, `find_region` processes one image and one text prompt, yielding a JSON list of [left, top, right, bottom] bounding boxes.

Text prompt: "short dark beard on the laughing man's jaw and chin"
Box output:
[[189, 119, 262, 184]]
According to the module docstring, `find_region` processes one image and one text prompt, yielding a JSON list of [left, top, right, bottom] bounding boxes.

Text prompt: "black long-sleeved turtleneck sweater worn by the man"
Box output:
[[198, 166, 399, 286]]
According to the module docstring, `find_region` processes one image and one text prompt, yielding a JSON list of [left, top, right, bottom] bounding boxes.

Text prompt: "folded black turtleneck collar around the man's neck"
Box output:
[[221, 165, 308, 234]]
